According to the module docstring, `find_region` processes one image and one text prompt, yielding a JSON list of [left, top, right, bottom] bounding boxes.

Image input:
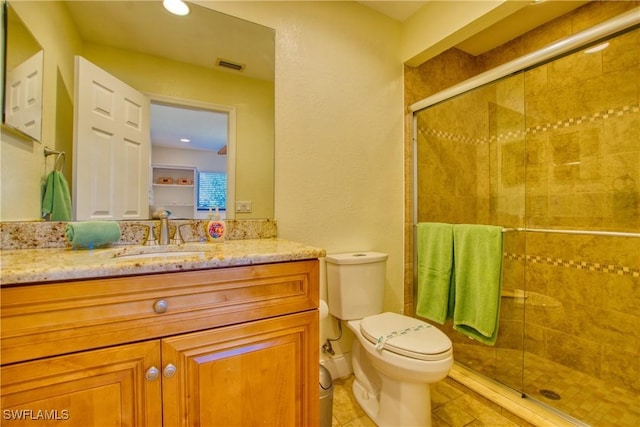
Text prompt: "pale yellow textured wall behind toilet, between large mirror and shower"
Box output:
[[203, 2, 404, 360]]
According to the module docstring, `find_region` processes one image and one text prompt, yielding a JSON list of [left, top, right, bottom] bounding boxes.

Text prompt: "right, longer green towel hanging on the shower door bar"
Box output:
[[453, 224, 503, 345]]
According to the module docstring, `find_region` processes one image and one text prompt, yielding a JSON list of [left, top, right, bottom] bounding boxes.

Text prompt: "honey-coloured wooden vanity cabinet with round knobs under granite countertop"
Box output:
[[0, 260, 319, 426]]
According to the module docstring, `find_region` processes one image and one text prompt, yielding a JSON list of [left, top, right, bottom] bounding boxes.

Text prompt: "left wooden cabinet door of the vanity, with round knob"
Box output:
[[0, 340, 162, 427]]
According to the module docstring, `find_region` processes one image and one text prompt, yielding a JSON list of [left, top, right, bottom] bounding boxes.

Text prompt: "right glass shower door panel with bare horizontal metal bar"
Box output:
[[524, 29, 640, 426]]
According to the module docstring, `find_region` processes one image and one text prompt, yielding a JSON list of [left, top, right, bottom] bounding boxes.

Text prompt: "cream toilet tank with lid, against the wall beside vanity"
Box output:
[[325, 252, 388, 320]]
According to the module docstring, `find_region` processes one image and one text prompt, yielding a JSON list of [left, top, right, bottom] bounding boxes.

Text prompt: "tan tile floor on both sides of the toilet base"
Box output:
[[332, 375, 532, 427]]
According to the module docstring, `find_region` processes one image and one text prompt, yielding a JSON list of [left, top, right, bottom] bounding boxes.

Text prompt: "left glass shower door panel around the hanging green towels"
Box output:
[[416, 73, 525, 391]]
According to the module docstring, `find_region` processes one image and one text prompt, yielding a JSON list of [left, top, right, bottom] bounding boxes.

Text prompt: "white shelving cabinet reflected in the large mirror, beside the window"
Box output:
[[149, 165, 197, 218]]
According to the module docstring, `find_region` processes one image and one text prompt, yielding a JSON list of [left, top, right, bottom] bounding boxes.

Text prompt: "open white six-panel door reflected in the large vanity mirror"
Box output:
[[73, 56, 151, 220]]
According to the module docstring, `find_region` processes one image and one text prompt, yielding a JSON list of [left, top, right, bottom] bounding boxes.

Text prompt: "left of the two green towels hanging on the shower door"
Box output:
[[416, 222, 454, 324]]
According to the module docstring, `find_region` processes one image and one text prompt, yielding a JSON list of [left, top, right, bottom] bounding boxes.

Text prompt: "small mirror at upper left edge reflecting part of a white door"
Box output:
[[2, 4, 44, 141]]
